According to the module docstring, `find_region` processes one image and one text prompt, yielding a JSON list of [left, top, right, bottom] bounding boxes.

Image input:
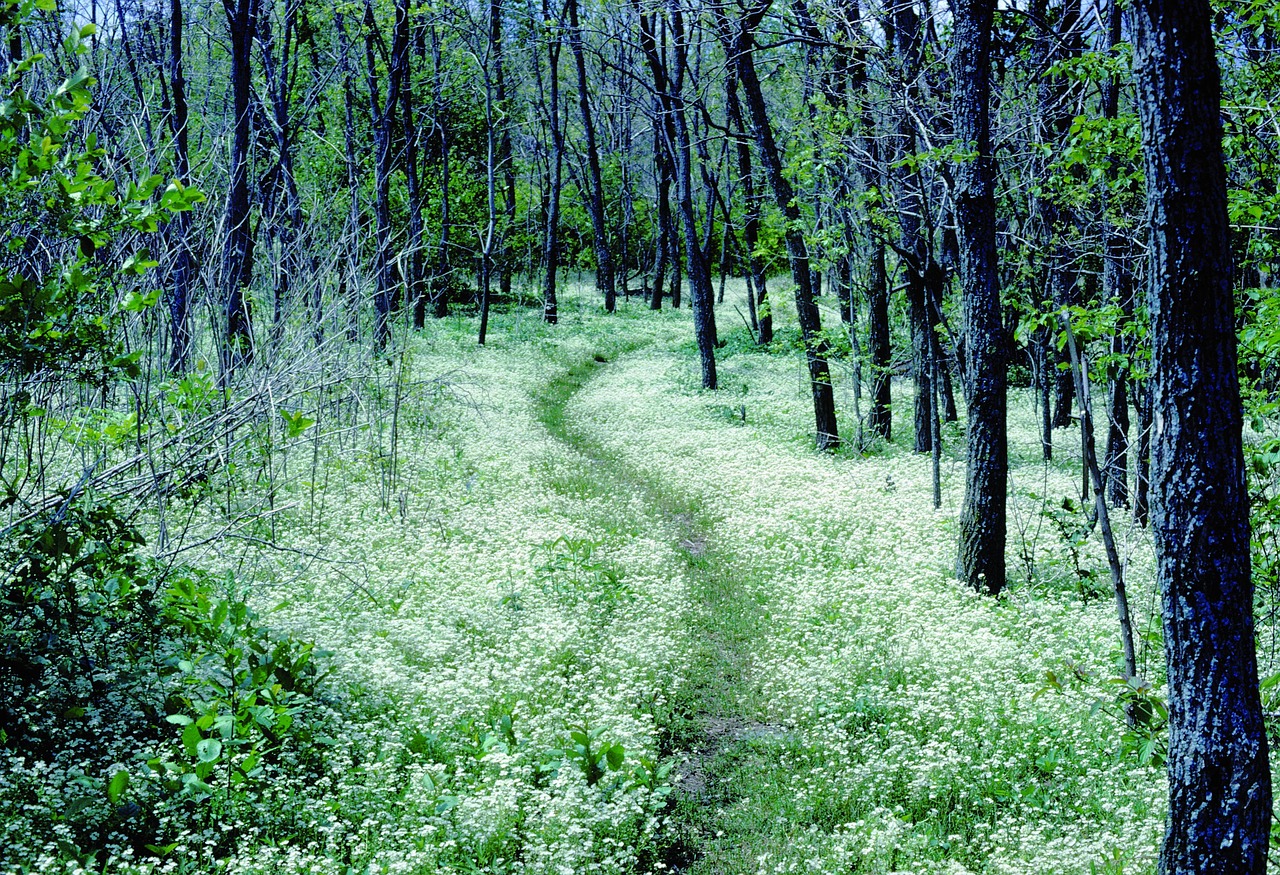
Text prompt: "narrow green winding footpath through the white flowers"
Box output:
[[534, 345, 786, 875]]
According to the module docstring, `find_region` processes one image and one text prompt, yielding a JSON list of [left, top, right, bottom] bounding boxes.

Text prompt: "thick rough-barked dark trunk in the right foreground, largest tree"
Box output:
[[1132, 0, 1271, 875]]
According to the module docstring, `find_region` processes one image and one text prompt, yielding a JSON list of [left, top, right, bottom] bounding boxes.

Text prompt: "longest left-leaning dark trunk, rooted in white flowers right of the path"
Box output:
[[719, 3, 840, 450]]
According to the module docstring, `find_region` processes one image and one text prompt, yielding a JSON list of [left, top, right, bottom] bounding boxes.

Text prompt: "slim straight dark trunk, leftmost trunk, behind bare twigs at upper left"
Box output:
[[169, 0, 195, 374]]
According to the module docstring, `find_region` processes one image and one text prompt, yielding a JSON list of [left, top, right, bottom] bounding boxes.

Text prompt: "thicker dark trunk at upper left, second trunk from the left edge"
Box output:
[[221, 0, 257, 372]]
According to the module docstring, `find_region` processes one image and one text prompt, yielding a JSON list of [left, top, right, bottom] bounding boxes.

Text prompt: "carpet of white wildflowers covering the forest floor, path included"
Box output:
[[0, 283, 1239, 875]]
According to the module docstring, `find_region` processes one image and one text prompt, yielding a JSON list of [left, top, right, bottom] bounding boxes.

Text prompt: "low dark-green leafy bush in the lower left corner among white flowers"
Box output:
[[0, 495, 340, 858]]
